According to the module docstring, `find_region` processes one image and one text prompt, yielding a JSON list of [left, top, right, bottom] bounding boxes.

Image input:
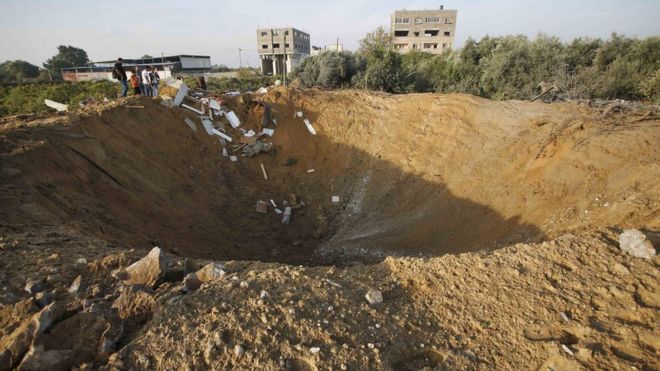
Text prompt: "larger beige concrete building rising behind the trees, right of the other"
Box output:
[[391, 6, 457, 54]]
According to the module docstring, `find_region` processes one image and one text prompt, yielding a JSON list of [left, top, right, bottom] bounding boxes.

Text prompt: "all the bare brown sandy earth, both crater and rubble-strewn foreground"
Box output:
[[0, 89, 660, 370]]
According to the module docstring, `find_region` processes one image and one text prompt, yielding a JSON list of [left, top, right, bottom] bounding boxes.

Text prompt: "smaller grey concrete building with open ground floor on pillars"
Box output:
[[257, 27, 311, 75]]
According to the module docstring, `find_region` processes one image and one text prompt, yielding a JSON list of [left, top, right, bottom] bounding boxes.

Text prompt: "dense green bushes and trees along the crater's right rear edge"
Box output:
[[291, 32, 660, 101]]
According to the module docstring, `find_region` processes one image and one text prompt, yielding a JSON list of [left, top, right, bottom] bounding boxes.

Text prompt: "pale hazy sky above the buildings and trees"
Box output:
[[0, 0, 660, 67]]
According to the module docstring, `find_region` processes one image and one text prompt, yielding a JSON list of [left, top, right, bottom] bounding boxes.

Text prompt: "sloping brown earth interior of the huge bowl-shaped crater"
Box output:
[[0, 89, 660, 264]]
